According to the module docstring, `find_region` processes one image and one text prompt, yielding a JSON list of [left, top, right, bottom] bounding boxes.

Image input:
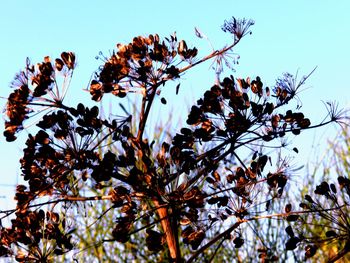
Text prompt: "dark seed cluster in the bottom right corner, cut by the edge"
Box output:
[[285, 176, 350, 259]]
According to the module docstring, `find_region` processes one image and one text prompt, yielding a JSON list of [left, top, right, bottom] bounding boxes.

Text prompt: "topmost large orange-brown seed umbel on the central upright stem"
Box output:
[[90, 34, 197, 101]]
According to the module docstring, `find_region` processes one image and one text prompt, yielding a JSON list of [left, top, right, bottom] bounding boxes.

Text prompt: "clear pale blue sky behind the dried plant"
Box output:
[[0, 0, 350, 210]]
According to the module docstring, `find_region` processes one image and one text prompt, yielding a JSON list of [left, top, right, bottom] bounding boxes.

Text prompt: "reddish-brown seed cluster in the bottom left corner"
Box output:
[[0, 192, 73, 262]]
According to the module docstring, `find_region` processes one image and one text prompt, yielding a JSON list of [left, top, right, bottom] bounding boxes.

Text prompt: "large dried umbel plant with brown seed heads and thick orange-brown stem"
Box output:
[[0, 18, 341, 262]]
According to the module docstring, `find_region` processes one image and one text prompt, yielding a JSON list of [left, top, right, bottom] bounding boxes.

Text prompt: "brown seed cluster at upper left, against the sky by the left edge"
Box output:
[[4, 52, 75, 141]]
